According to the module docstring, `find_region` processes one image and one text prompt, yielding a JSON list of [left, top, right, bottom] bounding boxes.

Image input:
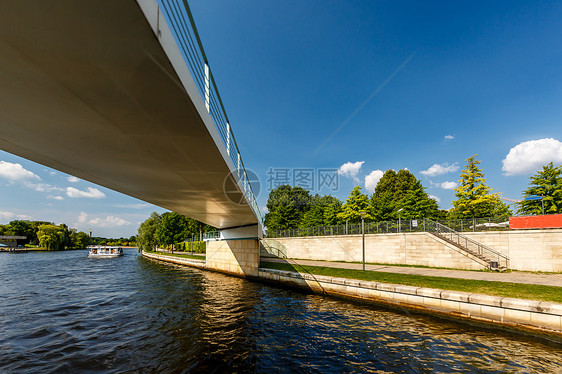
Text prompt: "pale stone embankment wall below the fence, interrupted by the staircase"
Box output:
[[261, 230, 562, 272]]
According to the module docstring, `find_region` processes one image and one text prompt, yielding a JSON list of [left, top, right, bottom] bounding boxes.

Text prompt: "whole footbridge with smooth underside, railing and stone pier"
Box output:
[[0, 0, 262, 275]]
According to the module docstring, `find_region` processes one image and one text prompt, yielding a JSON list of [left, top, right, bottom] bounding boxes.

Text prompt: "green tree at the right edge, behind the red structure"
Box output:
[[517, 162, 562, 215]]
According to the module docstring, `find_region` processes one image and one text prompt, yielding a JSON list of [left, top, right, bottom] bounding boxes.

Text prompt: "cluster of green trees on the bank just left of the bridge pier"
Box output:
[[137, 212, 216, 250]]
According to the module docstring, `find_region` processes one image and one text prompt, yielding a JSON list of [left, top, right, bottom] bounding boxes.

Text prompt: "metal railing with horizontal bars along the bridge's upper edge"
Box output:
[[157, 0, 263, 222]]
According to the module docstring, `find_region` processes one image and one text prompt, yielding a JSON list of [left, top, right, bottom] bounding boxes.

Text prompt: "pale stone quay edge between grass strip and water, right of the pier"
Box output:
[[259, 268, 562, 335]]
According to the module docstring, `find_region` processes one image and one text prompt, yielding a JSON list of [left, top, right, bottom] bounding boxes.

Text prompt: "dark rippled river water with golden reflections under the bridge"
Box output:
[[0, 249, 562, 373]]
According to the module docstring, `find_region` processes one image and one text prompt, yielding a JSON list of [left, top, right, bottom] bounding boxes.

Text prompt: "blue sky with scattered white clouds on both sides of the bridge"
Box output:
[[0, 0, 562, 237]]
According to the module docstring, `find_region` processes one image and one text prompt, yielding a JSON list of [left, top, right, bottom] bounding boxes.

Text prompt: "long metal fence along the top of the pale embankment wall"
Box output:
[[266, 217, 509, 238]]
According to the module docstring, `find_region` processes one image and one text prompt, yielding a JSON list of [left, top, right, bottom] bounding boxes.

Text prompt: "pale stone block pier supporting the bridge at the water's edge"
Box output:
[[206, 238, 260, 277]]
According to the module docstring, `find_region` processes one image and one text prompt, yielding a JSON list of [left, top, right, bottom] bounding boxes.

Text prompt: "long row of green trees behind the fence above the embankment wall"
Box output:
[[265, 155, 562, 230]]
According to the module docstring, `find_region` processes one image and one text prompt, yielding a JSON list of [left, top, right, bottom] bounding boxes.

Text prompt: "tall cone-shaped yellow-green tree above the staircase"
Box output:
[[451, 155, 509, 221]]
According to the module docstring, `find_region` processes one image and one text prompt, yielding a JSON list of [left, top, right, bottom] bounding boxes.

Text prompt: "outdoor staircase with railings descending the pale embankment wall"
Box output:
[[425, 220, 509, 271]]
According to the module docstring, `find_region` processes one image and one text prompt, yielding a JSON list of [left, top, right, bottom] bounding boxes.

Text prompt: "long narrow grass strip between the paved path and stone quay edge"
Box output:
[[260, 262, 562, 303]]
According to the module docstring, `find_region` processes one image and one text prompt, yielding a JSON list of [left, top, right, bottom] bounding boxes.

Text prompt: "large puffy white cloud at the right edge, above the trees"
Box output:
[[502, 138, 562, 175]]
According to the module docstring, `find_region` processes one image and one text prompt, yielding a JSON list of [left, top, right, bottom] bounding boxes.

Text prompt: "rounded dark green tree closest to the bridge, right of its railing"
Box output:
[[265, 185, 310, 230]]
